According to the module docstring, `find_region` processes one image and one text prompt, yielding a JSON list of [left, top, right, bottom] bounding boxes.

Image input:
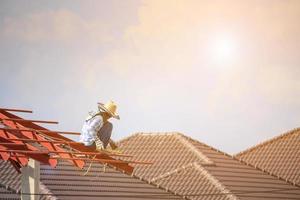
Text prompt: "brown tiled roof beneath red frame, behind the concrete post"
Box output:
[[0, 161, 183, 200]]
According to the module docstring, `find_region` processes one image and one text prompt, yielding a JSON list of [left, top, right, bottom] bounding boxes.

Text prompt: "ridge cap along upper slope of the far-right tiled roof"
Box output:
[[234, 127, 300, 157]]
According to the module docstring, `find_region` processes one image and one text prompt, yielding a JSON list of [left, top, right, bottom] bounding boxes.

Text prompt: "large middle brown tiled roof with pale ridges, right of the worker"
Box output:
[[119, 133, 300, 200]]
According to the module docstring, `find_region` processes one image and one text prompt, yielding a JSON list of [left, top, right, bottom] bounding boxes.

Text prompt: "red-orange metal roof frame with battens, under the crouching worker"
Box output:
[[0, 109, 140, 174]]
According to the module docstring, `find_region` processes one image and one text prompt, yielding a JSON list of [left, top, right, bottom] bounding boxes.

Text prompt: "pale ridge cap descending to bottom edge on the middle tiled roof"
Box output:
[[193, 162, 239, 200]]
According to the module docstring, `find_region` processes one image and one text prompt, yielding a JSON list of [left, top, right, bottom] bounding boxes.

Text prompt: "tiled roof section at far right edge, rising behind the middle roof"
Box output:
[[236, 128, 300, 187]]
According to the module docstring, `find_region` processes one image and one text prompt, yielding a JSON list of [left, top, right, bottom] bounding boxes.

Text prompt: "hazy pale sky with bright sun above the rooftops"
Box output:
[[0, 0, 300, 154]]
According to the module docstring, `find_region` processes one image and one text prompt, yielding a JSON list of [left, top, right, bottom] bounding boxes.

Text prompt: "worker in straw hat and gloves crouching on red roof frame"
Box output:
[[80, 101, 120, 149]]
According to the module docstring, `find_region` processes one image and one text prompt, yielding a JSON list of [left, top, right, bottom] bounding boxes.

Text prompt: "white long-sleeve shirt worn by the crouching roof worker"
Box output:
[[80, 113, 103, 146]]
